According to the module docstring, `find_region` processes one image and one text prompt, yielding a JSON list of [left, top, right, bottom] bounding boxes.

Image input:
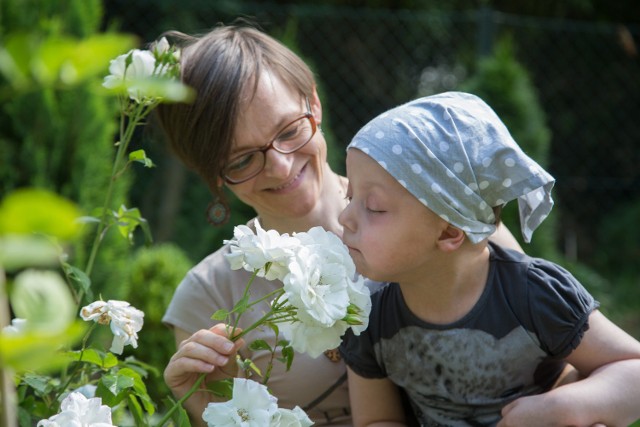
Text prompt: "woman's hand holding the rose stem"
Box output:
[[164, 323, 244, 420]]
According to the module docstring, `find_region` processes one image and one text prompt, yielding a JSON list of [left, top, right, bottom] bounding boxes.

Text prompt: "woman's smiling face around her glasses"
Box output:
[[224, 72, 327, 222]]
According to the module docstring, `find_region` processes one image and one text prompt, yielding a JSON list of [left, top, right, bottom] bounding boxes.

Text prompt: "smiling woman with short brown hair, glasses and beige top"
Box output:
[[157, 26, 519, 426]]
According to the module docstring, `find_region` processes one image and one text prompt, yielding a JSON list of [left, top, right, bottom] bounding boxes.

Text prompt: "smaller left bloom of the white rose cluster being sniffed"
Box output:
[[225, 221, 300, 280]]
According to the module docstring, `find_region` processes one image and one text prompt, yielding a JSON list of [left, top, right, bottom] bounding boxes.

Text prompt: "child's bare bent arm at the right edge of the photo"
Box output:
[[498, 311, 640, 427]]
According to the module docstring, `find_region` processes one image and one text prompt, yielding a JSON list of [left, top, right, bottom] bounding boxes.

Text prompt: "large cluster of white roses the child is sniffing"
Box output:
[[226, 221, 371, 357]]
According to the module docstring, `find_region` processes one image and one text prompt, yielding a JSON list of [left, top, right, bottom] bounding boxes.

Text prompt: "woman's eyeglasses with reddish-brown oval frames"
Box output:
[[222, 98, 317, 184]]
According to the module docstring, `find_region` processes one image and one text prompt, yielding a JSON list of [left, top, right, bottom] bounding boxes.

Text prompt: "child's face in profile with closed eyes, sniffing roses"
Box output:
[[339, 149, 448, 283]]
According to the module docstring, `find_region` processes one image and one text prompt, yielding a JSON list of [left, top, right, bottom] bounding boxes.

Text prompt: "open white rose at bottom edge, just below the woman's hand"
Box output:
[[202, 378, 278, 427]]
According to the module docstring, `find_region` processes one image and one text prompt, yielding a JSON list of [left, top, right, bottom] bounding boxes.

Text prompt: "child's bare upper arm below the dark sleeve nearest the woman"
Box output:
[[347, 368, 405, 427]]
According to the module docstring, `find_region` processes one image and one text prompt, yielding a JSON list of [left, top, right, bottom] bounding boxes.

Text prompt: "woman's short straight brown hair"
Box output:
[[156, 24, 315, 195]]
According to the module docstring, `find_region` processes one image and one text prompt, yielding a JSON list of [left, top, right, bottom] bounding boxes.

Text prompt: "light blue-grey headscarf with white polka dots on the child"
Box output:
[[347, 92, 555, 243]]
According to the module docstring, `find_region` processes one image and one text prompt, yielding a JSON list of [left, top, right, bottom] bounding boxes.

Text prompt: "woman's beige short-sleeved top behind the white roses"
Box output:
[[163, 236, 351, 426]]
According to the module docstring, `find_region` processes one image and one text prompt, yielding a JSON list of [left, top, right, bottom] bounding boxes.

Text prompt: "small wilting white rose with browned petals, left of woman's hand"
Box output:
[[80, 300, 144, 354]]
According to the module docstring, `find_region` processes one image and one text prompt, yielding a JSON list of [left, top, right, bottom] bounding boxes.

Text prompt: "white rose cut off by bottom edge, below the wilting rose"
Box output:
[[38, 392, 116, 427]]
